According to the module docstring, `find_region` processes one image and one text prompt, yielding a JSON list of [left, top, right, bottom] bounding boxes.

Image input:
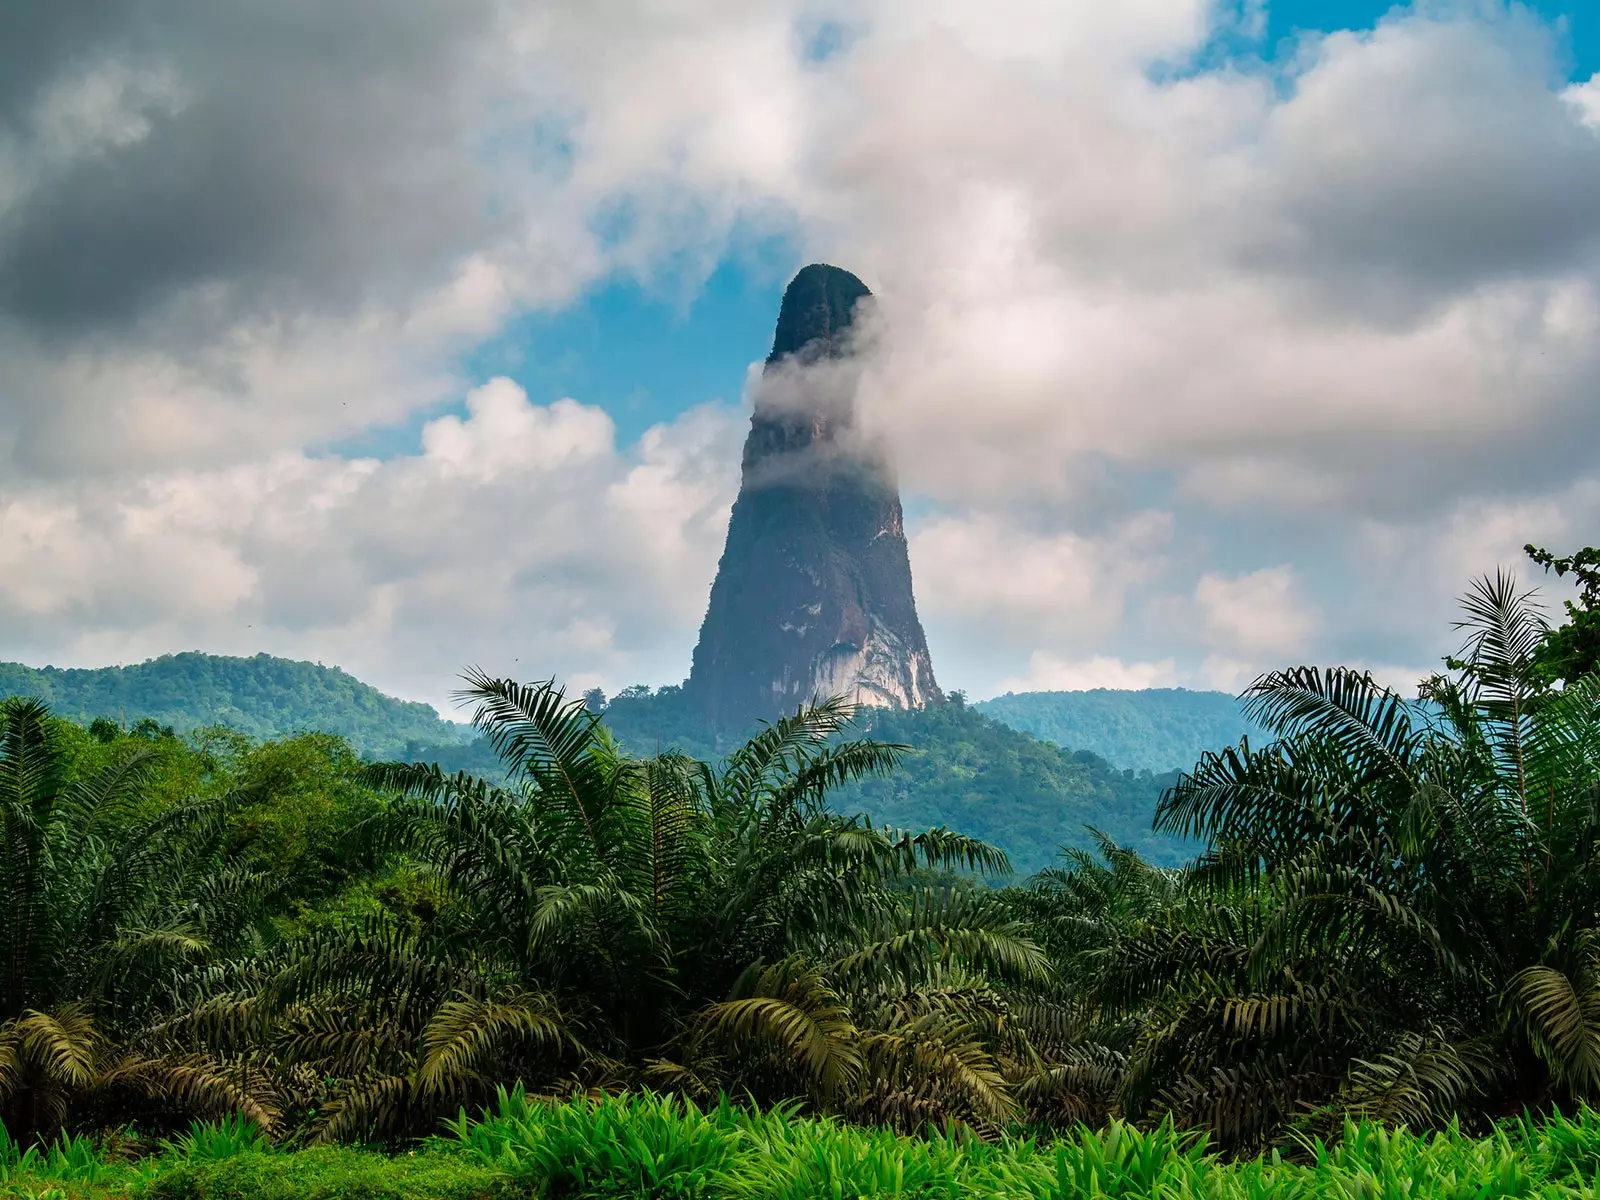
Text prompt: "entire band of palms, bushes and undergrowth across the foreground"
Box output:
[[0, 552, 1600, 1195]]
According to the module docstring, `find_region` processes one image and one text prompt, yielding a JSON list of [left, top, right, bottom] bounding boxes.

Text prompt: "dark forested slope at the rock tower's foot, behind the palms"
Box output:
[[605, 688, 1195, 875]]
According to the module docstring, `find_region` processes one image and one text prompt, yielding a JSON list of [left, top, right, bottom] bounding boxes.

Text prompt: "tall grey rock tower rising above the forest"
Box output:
[[688, 264, 944, 730]]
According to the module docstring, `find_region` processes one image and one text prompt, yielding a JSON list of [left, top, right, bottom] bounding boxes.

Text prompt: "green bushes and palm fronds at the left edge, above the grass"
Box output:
[[0, 710, 405, 1138]]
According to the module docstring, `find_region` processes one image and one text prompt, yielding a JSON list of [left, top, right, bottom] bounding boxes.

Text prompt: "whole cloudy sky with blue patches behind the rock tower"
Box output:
[[0, 0, 1600, 710]]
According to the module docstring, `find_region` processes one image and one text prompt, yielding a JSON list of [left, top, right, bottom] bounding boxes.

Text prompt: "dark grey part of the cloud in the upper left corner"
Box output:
[[0, 0, 499, 336]]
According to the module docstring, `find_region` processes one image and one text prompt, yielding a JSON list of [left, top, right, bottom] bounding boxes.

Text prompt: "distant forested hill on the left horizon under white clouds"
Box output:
[[0, 653, 462, 757]]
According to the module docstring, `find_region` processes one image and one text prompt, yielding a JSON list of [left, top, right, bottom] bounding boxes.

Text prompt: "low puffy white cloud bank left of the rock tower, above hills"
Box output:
[[0, 379, 739, 704]]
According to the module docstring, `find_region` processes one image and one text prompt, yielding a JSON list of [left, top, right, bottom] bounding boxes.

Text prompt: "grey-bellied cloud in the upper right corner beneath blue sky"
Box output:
[[1245, 11, 1600, 323]]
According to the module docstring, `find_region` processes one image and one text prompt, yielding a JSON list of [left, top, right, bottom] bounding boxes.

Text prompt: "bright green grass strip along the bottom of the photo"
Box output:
[[0, 1090, 1600, 1200]]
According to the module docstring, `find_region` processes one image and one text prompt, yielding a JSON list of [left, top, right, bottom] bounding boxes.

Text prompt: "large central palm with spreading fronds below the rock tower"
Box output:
[[241, 672, 1040, 1138]]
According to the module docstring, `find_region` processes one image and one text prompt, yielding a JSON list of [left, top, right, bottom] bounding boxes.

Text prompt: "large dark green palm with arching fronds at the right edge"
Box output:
[[1099, 574, 1600, 1144]]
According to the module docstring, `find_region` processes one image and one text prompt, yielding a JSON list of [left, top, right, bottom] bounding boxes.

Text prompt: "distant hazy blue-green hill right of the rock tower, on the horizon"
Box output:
[[973, 688, 1262, 771]]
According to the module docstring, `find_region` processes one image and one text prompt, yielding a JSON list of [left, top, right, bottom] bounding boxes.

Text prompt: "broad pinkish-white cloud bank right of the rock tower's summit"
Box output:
[[840, 14, 1600, 512]]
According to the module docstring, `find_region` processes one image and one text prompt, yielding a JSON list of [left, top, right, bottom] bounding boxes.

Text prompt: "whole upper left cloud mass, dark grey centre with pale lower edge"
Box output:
[[0, 0, 608, 480]]
